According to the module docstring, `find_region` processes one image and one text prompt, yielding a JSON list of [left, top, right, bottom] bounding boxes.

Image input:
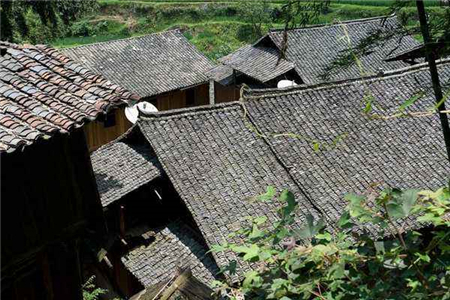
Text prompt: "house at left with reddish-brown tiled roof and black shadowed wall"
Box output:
[[0, 42, 138, 300]]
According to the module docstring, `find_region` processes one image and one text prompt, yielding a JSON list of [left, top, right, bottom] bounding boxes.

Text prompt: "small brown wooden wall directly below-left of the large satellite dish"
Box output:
[[84, 107, 133, 152]]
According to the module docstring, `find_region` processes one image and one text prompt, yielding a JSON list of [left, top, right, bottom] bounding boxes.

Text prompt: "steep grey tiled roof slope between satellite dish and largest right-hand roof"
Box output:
[[139, 102, 317, 266]]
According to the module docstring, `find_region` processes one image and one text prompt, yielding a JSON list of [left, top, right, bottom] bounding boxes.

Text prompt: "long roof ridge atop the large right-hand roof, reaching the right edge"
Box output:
[[241, 58, 450, 99]]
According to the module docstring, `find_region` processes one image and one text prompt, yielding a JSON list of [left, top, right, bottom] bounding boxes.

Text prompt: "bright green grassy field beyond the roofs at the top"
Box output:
[[51, 0, 446, 60]]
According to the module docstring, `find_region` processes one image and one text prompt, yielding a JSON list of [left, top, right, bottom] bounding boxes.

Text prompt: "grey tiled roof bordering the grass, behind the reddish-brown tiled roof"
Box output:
[[64, 30, 214, 97]]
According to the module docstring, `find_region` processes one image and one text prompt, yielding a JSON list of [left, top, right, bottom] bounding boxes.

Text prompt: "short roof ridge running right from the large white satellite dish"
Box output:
[[138, 101, 242, 119]]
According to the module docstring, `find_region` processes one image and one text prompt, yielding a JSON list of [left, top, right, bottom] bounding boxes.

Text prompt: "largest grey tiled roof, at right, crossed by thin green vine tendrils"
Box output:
[[244, 61, 450, 221]]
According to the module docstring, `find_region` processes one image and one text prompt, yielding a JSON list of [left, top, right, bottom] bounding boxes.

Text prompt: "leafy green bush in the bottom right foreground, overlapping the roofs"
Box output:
[[213, 187, 450, 300]]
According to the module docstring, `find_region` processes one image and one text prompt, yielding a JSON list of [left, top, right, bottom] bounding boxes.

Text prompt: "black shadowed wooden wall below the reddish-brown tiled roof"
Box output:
[[0, 129, 106, 300]]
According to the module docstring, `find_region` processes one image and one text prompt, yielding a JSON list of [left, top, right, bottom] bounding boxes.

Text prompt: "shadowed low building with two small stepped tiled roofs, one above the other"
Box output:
[[91, 125, 219, 297]]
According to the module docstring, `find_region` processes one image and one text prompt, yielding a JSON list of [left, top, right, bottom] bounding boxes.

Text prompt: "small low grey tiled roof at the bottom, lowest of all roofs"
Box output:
[[122, 221, 219, 287]]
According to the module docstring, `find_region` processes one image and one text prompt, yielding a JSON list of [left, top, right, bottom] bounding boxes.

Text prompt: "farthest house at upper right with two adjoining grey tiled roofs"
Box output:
[[219, 16, 420, 90]]
